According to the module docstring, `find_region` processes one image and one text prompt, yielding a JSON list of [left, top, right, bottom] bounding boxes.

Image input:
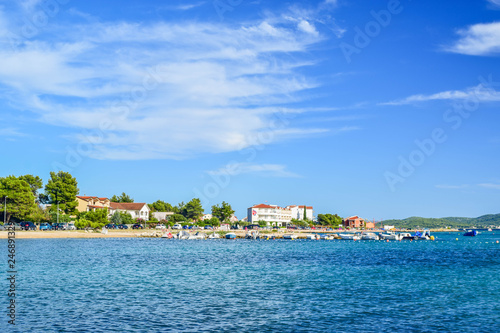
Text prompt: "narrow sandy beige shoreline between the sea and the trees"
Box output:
[[0, 229, 459, 239]]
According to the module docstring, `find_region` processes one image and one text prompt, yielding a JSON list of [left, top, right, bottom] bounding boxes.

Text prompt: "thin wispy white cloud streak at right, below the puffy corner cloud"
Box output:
[[381, 82, 500, 105]]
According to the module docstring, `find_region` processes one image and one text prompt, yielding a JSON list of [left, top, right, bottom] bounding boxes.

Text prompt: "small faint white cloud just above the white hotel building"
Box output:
[[207, 163, 300, 178]]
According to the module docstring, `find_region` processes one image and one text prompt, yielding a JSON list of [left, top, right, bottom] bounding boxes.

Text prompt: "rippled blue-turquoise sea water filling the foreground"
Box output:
[[0, 232, 500, 332]]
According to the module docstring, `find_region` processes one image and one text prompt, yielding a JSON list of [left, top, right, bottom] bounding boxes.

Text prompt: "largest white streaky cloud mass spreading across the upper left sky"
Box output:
[[0, 14, 334, 160]]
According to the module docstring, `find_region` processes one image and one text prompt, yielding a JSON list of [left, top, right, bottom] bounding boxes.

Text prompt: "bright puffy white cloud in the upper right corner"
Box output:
[[445, 22, 500, 56]]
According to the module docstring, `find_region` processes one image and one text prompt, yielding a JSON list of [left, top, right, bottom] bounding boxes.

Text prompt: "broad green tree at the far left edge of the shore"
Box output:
[[0, 176, 36, 222]]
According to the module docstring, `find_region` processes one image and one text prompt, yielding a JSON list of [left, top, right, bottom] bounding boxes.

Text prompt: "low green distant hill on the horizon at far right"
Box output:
[[382, 214, 500, 228]]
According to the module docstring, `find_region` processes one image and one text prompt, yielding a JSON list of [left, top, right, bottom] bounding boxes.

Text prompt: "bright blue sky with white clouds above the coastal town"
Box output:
[[0, 0, 500, 221]]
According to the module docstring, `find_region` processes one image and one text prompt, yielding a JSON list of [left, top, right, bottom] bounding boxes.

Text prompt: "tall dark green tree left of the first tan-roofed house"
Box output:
[[45, 171, 80, 214]]
